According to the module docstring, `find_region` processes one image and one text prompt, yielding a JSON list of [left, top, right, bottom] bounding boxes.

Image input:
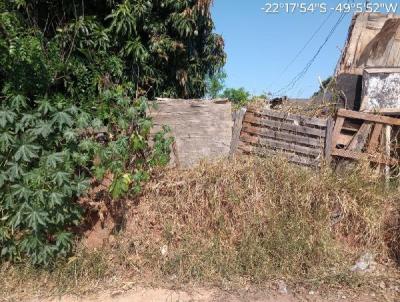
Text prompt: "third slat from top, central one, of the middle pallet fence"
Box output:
[[242, 123, 323, 147]]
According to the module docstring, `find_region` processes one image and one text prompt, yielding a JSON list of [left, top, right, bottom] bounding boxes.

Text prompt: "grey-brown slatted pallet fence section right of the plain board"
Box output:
[[237, 108, 333, 167]]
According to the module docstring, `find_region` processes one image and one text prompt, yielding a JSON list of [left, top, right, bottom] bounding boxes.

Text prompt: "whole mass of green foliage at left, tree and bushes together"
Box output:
[[0, 0, 224, 264]]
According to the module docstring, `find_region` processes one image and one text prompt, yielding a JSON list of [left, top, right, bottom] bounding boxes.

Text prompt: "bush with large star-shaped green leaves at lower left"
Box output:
[[0, 89, 88, 264]]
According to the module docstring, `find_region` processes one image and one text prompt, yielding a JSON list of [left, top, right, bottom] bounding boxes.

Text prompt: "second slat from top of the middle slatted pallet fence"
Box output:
[[244, 113, 325, 137]]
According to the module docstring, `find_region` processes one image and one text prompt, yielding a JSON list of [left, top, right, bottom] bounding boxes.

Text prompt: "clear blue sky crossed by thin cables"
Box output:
[[212, 0, 399, 97]]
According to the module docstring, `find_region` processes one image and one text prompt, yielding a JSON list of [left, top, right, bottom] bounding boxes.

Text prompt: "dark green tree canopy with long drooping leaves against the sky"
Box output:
[[1, 0, 225, 97]]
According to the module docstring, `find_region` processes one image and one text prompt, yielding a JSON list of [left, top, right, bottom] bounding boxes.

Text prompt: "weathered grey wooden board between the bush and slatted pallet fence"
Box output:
[[150, 100, 233, 168]]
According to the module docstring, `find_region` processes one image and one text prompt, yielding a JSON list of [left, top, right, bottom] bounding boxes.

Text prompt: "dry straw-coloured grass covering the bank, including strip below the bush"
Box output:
[[0, 157, 399, 300]]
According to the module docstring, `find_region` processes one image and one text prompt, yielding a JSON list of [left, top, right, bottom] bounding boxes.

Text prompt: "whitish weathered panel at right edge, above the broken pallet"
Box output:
[[361, 68, 400, 113]]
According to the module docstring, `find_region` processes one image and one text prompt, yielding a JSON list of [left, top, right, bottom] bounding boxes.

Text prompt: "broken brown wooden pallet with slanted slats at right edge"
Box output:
[[330, 109, 400, 165]]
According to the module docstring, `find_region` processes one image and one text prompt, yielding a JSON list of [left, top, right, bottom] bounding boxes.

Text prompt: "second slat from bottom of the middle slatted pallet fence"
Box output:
[[240, 133, 321, 156]]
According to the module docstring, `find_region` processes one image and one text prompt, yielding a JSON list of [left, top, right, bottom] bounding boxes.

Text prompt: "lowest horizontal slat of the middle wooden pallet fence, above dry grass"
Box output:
[[238, 142, 320, 167]]
